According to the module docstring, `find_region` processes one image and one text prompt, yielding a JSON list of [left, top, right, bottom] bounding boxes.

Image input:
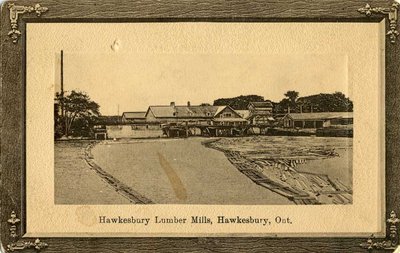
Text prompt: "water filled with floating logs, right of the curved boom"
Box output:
[[203, 136, 353, 204]]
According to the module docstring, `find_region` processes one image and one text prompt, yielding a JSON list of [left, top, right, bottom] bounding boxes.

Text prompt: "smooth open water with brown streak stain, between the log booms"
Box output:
[[92, 137, 294, 205]]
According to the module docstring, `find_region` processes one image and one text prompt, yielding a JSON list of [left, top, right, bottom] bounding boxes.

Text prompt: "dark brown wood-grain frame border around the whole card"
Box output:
[[0, 0, 400, 252]]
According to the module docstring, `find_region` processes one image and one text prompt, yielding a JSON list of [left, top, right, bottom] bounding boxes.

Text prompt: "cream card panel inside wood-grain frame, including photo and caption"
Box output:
[[22, 23, 384, 237]]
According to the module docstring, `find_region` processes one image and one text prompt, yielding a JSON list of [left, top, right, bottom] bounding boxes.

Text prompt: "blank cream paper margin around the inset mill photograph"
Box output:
[[26, 23, 385, 237]]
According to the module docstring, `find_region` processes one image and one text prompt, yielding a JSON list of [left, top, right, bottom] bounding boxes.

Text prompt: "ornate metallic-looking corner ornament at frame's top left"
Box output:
[[8, 3, 48, 43]]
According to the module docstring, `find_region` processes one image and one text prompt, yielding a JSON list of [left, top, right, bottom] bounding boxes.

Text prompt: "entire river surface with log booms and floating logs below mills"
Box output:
[[55, 137, 352, 205]]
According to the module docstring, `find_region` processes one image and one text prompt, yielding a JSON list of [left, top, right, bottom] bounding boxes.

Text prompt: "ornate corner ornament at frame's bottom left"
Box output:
[[7, 211, 48, 252]]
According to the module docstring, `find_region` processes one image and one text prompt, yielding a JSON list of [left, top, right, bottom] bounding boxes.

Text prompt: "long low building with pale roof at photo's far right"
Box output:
[[281, 112, 353, 128]]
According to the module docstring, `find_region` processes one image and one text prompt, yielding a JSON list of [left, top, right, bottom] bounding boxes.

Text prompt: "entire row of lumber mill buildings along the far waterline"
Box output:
[[96, 101, 353, 139]]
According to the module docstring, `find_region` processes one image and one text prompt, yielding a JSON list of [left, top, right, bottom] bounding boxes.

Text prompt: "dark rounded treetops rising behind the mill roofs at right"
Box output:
[[213, 91, 353, 114]]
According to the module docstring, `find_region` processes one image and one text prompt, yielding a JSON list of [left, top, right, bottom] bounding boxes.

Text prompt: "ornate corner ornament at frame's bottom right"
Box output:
[[360, 211, 400, 250]]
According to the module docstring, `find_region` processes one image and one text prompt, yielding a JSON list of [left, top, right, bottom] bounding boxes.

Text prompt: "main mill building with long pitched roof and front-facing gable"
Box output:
[[98, 102, 255, 139]]
